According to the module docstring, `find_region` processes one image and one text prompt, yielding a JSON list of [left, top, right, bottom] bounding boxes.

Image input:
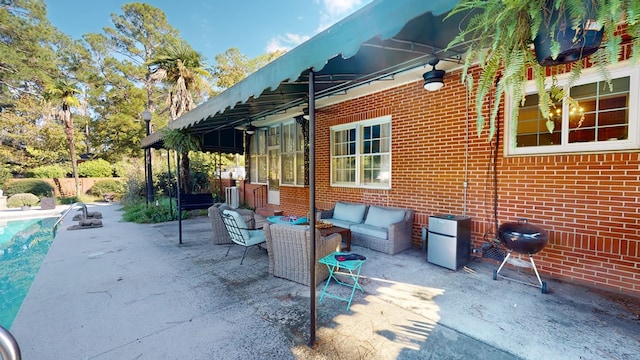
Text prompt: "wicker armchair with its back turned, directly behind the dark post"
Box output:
[[264, 224, 342, 286]]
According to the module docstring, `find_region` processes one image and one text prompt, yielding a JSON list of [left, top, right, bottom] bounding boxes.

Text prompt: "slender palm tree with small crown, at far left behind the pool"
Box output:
[[44, 79, 80, 197]]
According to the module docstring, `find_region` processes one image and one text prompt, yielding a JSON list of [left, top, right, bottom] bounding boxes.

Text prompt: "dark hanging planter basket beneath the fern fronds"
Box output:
[[533, 0, 604, 66]]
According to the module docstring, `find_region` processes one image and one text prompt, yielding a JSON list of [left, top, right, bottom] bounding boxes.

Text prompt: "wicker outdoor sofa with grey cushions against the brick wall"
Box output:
[[321, 201, 414, 255]]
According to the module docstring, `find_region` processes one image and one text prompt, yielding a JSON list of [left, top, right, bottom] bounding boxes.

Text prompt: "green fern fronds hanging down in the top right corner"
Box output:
[[447, 0, 640, 139]]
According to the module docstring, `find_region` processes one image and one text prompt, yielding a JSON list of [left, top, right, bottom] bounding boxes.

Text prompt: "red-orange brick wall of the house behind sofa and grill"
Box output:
[[272, 68, 640, 295]]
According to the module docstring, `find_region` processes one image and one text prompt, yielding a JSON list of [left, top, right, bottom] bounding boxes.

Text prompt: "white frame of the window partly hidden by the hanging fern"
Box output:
[[504, 61, 640, 156]]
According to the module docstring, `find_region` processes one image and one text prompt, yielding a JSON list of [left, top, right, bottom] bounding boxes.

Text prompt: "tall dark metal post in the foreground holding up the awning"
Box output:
[[309, 70, 316, 347]]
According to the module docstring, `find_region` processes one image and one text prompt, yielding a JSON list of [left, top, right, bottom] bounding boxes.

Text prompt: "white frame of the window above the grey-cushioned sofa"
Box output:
[[329, 115, 393, 190]]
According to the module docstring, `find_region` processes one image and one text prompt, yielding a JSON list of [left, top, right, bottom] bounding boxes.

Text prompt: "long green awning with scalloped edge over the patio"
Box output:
[[142, 0, 465, 152]]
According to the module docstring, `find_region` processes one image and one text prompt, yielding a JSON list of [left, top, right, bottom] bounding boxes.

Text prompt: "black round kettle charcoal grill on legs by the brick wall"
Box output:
[[493, 219, 549, 294]]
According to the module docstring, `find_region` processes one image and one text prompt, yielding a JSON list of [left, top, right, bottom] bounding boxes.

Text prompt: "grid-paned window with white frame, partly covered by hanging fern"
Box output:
[[507, 67, 640, 155]]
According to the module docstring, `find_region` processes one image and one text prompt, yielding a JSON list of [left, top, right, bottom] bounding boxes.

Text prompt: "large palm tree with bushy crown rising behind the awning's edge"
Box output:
[[147, 43, 211, 194]]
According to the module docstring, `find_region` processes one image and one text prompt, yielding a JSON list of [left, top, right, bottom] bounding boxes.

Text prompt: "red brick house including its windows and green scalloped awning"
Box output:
[[143, 0, 640, 295]]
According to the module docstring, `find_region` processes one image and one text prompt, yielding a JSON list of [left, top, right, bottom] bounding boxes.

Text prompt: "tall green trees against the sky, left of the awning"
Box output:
[[0, 0, 282, 194]]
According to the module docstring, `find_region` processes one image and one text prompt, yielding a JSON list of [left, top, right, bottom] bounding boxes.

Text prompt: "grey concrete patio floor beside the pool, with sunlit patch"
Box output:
[[6, 204, 640, 359]]
